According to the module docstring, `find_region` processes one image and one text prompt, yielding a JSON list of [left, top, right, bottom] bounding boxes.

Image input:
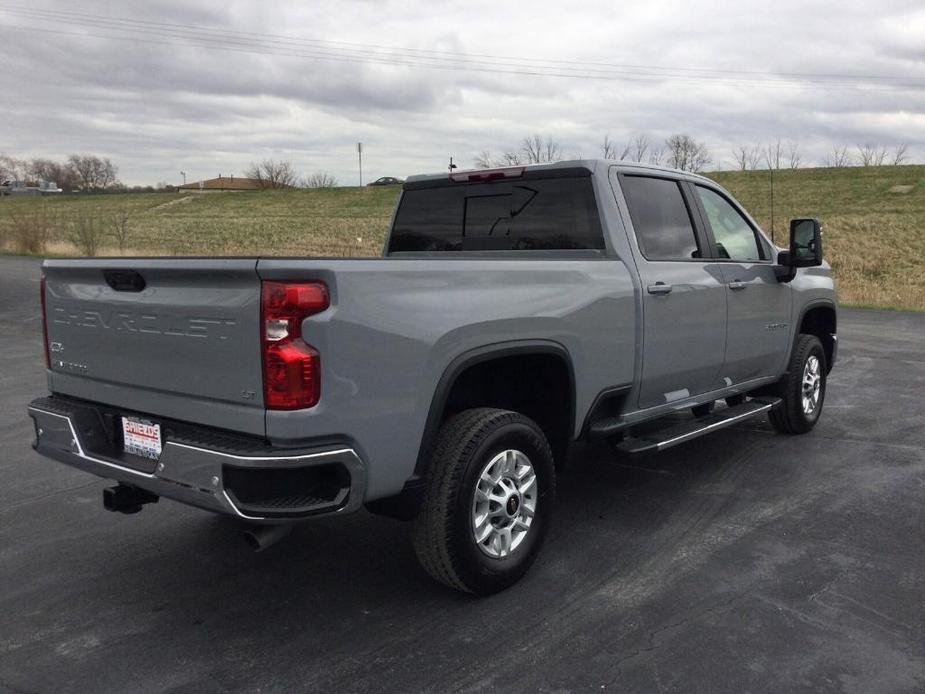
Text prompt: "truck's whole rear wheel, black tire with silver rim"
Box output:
[[412, 408, 556, 595]]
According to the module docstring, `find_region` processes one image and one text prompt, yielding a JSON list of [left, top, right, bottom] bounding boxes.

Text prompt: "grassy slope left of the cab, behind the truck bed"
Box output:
[[0, 186, 399, 255]]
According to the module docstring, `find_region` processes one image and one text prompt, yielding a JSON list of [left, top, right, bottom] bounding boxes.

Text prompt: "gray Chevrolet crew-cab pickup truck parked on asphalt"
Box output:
[[29, 161, 837, 594]]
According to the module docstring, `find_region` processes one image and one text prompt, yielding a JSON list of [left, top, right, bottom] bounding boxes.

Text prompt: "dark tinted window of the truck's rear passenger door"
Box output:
[[622, 176, 701, 260]]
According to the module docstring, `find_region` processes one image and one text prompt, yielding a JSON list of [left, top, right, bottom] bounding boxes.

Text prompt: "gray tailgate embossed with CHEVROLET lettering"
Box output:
[[44, 258, 265, 435]]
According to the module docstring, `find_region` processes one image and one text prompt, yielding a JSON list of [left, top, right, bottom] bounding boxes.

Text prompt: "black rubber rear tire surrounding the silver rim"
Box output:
[[412, 408, 556, 595]]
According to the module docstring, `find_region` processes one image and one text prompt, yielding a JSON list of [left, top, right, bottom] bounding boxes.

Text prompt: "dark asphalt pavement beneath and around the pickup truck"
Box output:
[[0, 257, 925, 694]]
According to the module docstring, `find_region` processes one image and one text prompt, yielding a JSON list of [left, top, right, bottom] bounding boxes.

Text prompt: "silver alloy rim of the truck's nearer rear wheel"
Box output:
[[472, 449, 538, 559]]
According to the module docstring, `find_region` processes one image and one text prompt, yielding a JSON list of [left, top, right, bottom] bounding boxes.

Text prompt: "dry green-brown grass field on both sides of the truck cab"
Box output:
[[0, 166, 925, 310]]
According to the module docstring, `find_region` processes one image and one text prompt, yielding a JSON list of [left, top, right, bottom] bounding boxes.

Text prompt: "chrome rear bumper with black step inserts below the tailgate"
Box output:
[[29, 398, 366, 523]]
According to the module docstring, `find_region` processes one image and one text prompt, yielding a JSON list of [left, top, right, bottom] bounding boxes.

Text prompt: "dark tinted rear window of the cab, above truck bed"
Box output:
[[389, 176, 604, 253]]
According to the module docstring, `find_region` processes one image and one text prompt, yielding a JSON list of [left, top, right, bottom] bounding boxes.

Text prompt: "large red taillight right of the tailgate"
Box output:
[[261, 282, 330, 410]]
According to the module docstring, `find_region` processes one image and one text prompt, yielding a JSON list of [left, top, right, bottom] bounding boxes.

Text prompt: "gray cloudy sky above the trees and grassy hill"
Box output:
[[0, 0, 925, 184]]
